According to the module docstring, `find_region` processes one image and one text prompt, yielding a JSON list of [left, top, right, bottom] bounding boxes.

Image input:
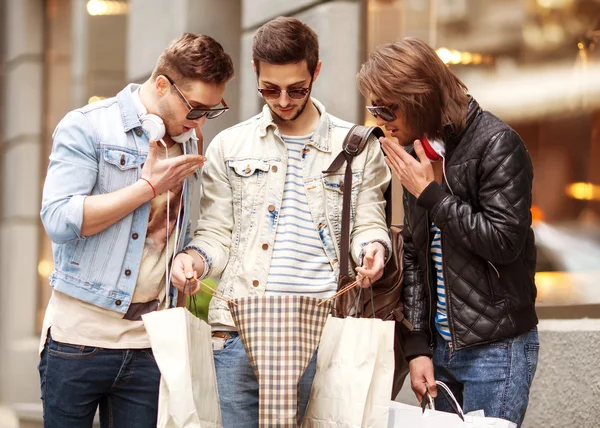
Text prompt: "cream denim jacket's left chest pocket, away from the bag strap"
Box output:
[[227, 159, 270, 210]]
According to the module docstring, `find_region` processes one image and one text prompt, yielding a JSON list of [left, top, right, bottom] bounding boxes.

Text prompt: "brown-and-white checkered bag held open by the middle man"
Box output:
[[229, 295, 331, 428]]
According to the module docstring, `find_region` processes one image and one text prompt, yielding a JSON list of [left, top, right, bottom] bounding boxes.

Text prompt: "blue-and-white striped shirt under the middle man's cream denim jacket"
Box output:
[[266, 135, 337, 298]]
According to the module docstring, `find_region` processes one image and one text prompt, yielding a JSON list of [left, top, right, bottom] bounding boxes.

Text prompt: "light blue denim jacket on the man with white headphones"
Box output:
[[41, 84, 200, 313]]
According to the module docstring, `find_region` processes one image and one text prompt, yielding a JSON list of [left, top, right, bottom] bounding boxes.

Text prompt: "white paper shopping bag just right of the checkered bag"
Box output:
[[302, 316, 395, 428]]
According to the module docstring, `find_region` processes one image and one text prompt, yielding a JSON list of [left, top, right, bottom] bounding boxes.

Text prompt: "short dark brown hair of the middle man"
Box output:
[[252, 16, 319, 76]]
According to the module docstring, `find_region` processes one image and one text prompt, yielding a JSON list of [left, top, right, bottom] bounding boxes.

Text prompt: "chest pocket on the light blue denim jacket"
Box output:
[[98, 148, 145, 193]]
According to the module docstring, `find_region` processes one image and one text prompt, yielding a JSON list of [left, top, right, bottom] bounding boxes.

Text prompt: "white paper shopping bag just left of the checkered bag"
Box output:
[[142, 308, 223, 428]]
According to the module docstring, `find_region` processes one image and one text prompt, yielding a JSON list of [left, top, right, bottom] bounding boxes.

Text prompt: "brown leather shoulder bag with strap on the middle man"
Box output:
[[323, 125, 412, 399]]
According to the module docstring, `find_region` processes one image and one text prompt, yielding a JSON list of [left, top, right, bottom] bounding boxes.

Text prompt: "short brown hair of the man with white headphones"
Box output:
[[152, 33, 233, 85]]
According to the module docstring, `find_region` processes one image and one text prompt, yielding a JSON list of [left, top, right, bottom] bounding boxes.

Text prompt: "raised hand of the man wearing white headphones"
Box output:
[[142, 141, 206, 195]]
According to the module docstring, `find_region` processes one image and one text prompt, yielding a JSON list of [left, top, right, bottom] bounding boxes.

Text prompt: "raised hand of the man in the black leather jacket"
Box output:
[[379, 137, 435, 198]]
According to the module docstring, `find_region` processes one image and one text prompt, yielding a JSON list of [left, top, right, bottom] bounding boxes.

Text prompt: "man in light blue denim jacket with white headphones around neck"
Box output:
[[39, 34, 233, 428]]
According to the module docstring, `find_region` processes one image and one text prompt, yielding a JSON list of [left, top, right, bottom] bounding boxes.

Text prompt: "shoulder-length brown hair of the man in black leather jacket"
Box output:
[[357, 38, 468, 138]]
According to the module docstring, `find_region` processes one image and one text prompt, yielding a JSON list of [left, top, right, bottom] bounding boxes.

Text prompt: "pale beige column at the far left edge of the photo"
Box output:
[[0, 0, 44, 403]]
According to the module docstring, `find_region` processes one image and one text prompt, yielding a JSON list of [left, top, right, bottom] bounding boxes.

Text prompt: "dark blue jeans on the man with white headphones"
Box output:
[[38, 335, 160, 428]]
